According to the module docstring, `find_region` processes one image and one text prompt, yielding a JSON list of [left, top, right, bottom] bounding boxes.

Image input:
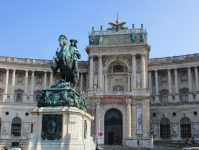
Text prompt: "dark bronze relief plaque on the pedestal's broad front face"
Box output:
[[41, 114, 62, 140]]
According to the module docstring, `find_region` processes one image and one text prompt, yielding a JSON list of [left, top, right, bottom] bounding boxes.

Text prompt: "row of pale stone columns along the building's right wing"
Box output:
[[149, 66, 199, 103]]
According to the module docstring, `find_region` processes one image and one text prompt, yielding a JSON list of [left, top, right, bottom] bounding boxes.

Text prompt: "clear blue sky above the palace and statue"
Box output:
[[0, 0, 199, 60]]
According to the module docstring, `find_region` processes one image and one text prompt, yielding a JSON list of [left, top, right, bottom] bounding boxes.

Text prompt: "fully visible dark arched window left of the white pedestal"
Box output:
[[11, 117, 21, 136]]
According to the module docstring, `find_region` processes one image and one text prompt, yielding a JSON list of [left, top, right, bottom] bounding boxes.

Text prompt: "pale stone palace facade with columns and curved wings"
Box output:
[[0, 25, 199, 147]]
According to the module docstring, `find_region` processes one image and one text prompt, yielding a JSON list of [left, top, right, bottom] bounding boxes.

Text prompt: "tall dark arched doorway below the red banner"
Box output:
[[104, 109, 122, 145]]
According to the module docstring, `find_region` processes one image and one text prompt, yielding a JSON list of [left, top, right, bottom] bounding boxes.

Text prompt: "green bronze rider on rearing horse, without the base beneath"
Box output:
[[51, 35, 81, 89]]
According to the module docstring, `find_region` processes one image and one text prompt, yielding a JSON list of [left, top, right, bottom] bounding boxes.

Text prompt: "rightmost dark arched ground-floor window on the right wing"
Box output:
[[180, 118, 191, 137]]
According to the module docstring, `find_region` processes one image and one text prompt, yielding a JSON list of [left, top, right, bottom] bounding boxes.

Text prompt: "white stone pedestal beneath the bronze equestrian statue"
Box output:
[[23, 106, 95, 150]]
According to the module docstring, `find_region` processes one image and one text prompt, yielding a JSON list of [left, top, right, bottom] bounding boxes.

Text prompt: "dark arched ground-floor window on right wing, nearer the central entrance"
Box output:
[[160, 118, 170, 137]]
